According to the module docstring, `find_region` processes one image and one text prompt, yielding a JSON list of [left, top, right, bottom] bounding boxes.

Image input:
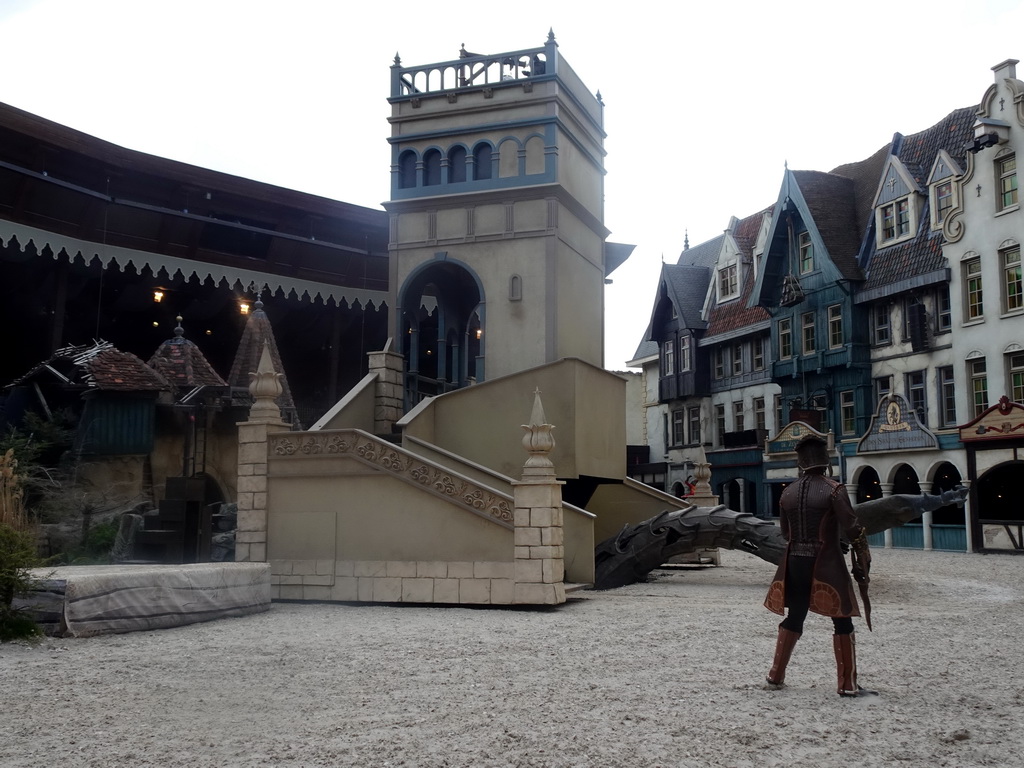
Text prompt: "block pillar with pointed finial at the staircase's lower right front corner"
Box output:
[[512, 389, 565, 605]]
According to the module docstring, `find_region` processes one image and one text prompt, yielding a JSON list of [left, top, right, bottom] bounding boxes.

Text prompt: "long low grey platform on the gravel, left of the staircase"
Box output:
[[19, 562, 270, 637]]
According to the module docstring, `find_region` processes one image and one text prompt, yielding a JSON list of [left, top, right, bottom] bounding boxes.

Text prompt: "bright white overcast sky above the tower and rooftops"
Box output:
[[0, 0, 1024, 370]]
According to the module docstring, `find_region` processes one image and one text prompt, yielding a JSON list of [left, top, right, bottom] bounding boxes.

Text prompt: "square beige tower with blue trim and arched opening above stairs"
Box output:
[[385, 34, 614, 407]]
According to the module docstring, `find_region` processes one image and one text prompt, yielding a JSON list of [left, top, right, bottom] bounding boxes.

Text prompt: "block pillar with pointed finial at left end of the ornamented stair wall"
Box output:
[[234, 343, 288, 562]]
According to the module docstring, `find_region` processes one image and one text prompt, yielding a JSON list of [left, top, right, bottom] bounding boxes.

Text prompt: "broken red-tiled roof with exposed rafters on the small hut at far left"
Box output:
[[9, 340, 171, 392]]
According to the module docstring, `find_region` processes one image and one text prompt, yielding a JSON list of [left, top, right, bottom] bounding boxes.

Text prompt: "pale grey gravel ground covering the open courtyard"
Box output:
[[0, 550, 1024, 768]]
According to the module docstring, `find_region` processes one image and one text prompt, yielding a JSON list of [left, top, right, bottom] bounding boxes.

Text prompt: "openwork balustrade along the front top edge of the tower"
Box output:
[[391, 41, 557, 98]]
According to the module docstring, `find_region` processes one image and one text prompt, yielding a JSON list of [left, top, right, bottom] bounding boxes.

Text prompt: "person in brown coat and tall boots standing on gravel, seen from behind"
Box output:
[[765, 434, 877, 696]]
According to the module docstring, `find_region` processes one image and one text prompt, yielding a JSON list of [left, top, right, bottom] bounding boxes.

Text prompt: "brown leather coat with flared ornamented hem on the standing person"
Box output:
[[765, 474, 860, 617]]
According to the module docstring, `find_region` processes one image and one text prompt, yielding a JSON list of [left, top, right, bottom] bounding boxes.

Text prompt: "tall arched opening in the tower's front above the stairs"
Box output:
[[398, 260, 483, 409]]
